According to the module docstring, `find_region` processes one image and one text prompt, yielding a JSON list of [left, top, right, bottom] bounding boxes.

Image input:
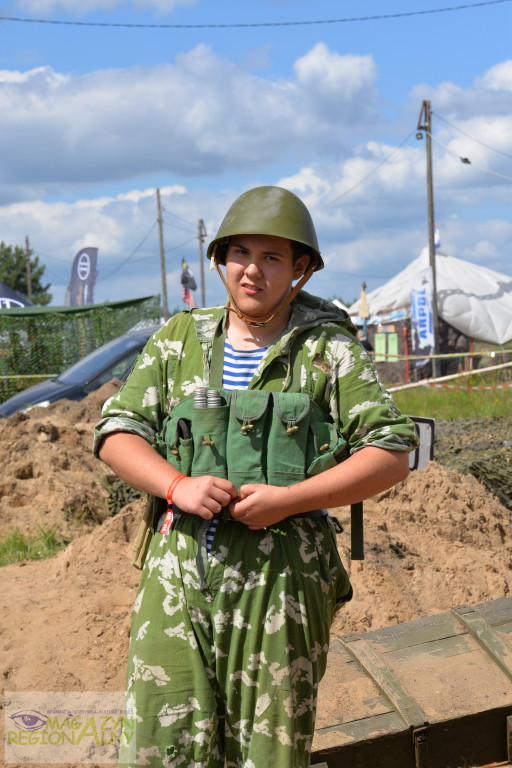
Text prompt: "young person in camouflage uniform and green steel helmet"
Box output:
[[95, 187, 417, 768]]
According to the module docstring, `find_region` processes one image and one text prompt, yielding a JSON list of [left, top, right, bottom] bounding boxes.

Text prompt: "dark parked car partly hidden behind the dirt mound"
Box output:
[[0, 325, 160, 416]]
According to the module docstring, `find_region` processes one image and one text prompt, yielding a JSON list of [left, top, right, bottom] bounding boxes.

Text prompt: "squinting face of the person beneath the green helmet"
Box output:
[[226, 235, 309, 318]]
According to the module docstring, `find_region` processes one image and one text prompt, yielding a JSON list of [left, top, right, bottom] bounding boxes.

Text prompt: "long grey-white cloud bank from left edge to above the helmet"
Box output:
[[0, 44, 380, 201]]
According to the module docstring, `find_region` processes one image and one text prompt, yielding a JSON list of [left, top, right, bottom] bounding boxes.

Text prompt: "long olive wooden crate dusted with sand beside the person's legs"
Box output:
[[311, 597, 512, 768]]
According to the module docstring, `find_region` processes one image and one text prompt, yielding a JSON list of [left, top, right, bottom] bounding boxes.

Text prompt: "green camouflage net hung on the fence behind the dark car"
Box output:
[[0, 296, 160, 402]]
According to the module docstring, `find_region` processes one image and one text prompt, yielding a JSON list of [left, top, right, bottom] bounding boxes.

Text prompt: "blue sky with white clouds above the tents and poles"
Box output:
[[0, 0, 512, 308]]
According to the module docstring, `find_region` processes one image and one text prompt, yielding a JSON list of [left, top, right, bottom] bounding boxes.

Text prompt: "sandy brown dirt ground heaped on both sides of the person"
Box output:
[[0, 383, 512, 760]]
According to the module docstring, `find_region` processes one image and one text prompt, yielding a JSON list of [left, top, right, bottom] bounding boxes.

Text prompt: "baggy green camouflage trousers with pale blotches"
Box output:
[[120, 515, 350, 768]]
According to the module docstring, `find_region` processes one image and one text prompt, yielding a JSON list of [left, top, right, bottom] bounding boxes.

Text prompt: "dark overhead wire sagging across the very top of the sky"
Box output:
[[0, 0, 511, 29]]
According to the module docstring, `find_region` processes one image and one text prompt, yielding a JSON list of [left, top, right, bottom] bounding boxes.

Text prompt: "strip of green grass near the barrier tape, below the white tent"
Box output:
[[392, 379, 512, 420]]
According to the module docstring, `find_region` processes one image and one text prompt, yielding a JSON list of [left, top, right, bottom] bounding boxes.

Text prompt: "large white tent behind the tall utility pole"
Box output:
[[349, 248, 512, 344]]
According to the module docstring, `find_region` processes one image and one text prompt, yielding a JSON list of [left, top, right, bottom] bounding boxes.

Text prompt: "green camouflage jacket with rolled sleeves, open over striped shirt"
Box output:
[[94, 291, 417, 455]]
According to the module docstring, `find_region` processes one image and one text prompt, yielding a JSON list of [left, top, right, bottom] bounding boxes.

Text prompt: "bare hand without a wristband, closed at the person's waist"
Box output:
[[229, 484, 292, 531]]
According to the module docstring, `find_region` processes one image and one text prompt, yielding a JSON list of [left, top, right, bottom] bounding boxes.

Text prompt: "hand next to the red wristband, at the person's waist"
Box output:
[[172, 475, 238, 520]]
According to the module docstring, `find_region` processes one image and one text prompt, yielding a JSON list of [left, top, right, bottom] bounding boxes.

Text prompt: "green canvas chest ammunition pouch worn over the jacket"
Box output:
[[156, 389, 346, 489]]
